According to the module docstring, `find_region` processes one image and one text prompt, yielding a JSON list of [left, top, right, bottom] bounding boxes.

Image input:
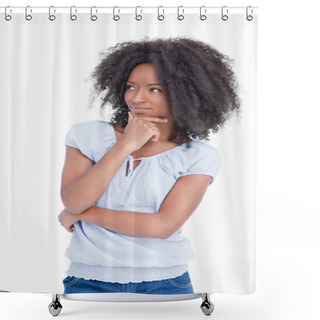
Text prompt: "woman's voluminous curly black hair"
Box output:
[[91, 38, 240, 144]]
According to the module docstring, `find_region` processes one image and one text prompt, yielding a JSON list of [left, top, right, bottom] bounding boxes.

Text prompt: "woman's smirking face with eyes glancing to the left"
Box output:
[[124, 63, 172, 120]]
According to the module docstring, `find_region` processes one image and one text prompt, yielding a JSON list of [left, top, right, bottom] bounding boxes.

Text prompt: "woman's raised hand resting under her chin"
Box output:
[[121, 112, 168, 152]]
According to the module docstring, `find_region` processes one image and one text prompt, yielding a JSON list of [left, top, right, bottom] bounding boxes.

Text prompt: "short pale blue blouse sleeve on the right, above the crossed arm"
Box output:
[[179, 141, 221, 184]]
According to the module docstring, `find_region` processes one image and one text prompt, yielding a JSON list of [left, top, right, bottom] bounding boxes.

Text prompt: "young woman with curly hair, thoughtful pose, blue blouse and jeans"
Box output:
[[59, 38, 239, 294]]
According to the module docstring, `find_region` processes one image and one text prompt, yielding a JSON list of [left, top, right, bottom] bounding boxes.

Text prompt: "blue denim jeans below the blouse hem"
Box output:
[[63, 272, 193, 294]]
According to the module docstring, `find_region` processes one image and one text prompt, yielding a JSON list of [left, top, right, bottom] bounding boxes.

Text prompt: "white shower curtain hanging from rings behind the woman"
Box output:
[[0, 7, 258, 294]]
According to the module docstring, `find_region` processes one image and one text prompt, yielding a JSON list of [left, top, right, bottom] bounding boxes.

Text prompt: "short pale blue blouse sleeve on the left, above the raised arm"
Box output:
[[65, 120, 114, 162]]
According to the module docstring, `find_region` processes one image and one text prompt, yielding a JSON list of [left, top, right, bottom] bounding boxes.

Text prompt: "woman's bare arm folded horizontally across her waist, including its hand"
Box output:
[[60, 164, 211, 239]]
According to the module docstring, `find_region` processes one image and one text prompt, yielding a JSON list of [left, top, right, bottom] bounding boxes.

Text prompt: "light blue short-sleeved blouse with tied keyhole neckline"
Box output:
[[65, 120, 220, 283]]
